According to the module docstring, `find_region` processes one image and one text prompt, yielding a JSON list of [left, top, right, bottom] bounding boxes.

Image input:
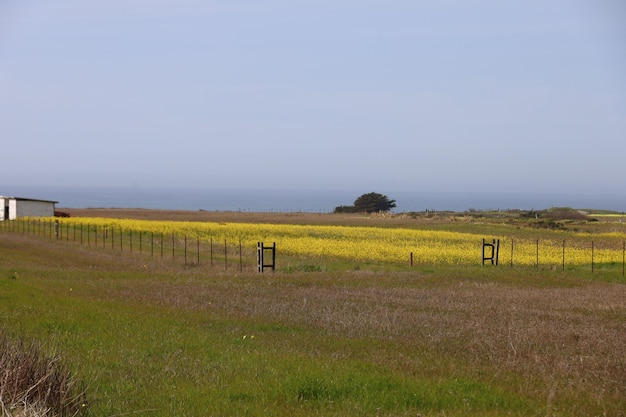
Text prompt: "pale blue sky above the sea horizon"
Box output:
[[0, 0, 626, 193]]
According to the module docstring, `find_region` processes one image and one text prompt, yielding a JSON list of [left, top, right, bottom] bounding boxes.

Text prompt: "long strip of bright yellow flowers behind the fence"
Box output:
[[14, 218, 626, 266]]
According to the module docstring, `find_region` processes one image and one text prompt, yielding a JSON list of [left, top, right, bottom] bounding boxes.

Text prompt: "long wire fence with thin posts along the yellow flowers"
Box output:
[[0, 218, 626, 276]]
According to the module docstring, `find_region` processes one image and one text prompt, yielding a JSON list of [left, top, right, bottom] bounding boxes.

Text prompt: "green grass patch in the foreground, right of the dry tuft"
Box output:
[[2, 277, 528, 416]]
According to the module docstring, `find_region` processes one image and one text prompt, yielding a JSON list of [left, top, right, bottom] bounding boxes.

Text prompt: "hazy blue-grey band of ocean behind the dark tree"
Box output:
[[0, 185, 626, 213]]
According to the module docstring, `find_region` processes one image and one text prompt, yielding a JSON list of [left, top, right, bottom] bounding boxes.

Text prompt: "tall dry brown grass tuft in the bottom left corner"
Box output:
[[0, 328, 86, 417]]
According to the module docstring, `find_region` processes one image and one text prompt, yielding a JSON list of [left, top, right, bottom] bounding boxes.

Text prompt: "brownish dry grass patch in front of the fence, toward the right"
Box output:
[[86, 271, 626, 410]]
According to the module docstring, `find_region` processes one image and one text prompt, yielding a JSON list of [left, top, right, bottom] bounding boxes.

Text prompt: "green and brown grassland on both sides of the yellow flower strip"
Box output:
[[0, 211, 626, 416]]
